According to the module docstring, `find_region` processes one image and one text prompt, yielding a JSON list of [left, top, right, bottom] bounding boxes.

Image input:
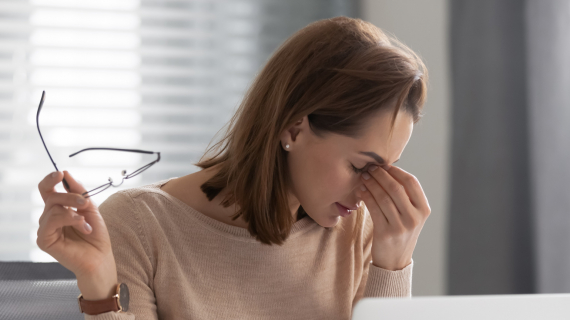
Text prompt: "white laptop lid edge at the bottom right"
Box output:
[[352, 293, 570, 320]]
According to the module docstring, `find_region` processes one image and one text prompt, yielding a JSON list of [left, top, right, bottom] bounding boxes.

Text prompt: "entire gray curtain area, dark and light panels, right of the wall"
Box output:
[[448, 0, 570, 294]]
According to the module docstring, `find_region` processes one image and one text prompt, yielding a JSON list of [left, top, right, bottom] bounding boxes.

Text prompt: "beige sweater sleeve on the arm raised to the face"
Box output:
[[353, 213, 414, 305]]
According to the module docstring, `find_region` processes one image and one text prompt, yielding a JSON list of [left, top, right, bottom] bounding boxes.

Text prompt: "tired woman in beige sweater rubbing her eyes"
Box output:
[[37, 17, 430, 319]]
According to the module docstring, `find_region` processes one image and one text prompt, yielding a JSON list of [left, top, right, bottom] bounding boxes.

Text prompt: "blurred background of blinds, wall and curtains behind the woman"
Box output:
[[0, 0, 570, 296]]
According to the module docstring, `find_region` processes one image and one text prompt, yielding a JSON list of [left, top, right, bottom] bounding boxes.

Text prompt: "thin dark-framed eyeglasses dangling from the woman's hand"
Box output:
[[36, 91, 160, 198]]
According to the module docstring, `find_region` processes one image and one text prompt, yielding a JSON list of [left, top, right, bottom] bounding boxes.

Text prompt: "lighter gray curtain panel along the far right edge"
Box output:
[[526, 0, 570, 293]]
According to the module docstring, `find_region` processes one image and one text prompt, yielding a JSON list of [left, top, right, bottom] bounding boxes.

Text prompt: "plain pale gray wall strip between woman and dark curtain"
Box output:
[[360, 0, 450, 296]]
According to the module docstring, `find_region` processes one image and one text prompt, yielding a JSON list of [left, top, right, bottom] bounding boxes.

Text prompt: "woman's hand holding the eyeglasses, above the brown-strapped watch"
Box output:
[[36, 171, 118, 300]]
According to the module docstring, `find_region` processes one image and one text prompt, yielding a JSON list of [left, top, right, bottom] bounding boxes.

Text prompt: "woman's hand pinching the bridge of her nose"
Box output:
[[357, 166, 431, 270]]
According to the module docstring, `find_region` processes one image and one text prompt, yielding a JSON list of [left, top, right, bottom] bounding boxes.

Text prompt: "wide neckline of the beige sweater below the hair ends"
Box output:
[[148, 177, 318, 242]]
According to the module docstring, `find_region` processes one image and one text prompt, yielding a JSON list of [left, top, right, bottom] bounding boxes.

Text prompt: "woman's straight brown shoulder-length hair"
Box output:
[[195, 17, 427, 245]]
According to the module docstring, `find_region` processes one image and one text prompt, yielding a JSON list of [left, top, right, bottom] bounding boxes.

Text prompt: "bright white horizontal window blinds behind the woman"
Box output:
[[0, 0, 353, 261]]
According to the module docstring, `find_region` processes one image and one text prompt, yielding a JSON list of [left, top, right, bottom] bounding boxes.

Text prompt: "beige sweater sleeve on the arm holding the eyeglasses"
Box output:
[[85, 191, 158, 320]]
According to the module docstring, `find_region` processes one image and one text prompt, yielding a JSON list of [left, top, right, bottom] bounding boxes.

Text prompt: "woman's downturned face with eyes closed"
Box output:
[[281, 109, 414, 227]]
